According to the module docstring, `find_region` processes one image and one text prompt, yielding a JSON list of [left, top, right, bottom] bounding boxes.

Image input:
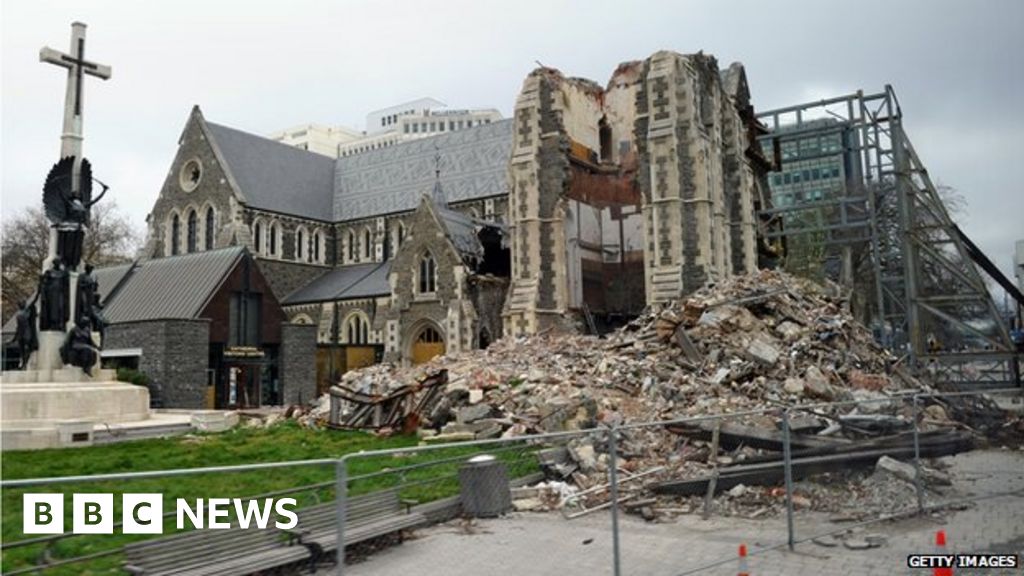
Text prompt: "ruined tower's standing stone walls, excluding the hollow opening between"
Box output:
[[505, 51, 764, 335]]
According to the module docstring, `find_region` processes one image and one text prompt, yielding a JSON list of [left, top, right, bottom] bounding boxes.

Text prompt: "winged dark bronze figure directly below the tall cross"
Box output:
[[43, 156, 108, 270]]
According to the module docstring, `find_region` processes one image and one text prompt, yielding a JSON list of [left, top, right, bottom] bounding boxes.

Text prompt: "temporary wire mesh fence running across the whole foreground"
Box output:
[[0, 390, 1024, 576]]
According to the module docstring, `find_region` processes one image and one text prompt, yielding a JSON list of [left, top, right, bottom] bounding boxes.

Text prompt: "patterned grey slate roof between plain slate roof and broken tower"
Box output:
[[334, 119, 513, 221]]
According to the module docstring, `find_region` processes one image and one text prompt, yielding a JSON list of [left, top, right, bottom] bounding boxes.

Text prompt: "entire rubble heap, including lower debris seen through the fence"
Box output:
[[305, 271, 1011, 518]]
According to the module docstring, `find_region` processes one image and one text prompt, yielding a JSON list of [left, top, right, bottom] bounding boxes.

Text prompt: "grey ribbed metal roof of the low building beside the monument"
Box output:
[[102, 246, 245, 324]]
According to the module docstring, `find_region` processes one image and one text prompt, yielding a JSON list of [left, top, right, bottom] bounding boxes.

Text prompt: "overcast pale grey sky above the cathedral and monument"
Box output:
[[0, 0, 1024, 280]]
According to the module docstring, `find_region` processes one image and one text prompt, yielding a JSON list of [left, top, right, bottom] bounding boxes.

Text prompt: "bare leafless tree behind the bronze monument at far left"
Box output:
[[0, 201, 140, 323]]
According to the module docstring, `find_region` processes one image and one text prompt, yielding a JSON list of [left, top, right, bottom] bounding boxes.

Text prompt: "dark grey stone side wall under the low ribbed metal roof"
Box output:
[[104, 320, 210, 409]]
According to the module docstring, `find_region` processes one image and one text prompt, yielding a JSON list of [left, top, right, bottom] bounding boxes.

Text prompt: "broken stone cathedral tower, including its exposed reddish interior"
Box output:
[[504, 51, 769, 335]]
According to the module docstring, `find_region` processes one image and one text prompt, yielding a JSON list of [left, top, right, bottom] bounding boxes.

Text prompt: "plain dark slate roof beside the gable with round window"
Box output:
[[206, 122, 335, 221]]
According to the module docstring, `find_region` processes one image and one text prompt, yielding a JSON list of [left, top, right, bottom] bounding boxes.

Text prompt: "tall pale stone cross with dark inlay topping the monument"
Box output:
[[39, 22, 111, 193]]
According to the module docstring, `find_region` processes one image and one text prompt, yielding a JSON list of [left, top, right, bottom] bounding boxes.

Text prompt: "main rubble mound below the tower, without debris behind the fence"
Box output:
[[331, 271, 919, 435]]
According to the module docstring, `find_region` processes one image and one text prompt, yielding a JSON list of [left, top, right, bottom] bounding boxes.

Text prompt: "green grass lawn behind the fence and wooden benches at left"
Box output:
[[0, 421, 538, 574]]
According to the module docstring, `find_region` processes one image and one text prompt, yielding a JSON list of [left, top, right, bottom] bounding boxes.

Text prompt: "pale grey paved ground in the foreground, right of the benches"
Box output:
[[345, 450, 1024, 576]]
